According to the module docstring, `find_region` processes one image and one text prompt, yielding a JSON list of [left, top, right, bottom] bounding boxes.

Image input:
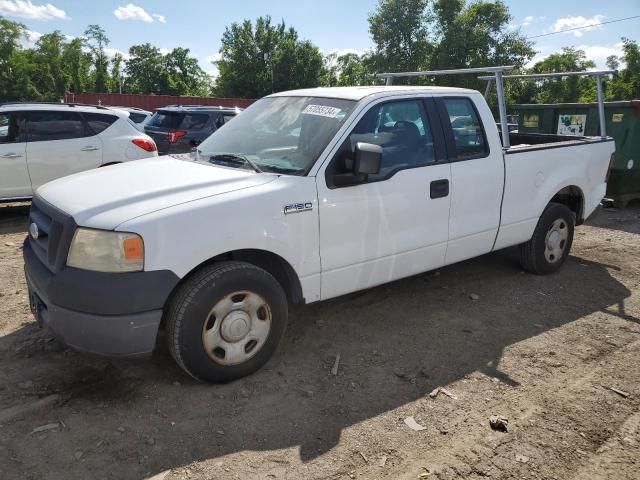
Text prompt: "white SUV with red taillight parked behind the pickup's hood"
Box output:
[[0, 103, 158, 201]]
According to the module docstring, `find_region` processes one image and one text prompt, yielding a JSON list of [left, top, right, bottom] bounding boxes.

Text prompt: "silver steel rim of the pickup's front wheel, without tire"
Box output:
[[202, 291, 271, 365]]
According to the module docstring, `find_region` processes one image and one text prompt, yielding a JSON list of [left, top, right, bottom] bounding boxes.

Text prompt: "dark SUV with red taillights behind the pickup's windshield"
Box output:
[[144, 105, 242, 155]]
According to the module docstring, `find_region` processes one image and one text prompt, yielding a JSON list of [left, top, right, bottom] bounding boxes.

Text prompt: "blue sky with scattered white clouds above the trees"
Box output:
[[0, 0, 640, 75]]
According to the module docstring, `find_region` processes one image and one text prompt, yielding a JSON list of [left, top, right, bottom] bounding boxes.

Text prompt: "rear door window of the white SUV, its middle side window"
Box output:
[[27, 111, 93, 142]]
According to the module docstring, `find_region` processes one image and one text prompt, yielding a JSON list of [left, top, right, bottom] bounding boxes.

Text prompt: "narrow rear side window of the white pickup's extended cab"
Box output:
[[443, 98, 489, 160]]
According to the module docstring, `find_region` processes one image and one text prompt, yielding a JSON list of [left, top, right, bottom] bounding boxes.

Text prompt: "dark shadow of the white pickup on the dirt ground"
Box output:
[[0, 251, 640, 479]]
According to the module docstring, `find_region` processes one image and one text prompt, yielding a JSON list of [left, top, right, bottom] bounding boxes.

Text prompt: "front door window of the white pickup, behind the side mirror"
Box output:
[[337, 100, 436, 182]]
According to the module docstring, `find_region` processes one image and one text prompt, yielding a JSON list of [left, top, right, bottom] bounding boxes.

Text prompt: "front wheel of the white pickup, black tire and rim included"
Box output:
[[167, 261, 288, 383]]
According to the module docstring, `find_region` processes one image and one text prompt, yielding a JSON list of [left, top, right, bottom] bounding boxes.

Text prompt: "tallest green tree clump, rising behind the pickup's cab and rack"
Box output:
[[364, 0, 535, 88]]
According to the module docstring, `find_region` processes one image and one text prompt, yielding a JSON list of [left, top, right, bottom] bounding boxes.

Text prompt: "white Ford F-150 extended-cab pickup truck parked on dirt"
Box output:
[[24, 86, 614, 382]]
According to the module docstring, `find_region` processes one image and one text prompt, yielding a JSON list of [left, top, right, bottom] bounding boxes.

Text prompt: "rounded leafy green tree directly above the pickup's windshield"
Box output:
[[216, 16, 323, 98]]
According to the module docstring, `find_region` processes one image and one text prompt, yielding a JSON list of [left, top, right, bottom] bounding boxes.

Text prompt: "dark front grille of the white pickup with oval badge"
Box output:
[[29, 197, 76, 272]]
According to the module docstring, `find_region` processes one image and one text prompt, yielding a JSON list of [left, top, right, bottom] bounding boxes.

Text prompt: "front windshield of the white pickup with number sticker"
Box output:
[[198, 97, 356, 175]]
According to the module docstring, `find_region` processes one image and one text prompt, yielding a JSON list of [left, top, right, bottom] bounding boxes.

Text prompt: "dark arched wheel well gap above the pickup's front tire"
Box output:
[[167, 249, 304, 305]]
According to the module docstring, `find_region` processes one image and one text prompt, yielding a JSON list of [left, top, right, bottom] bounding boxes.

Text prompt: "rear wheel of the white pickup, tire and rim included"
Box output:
[[520, 203, 575, 275]]
